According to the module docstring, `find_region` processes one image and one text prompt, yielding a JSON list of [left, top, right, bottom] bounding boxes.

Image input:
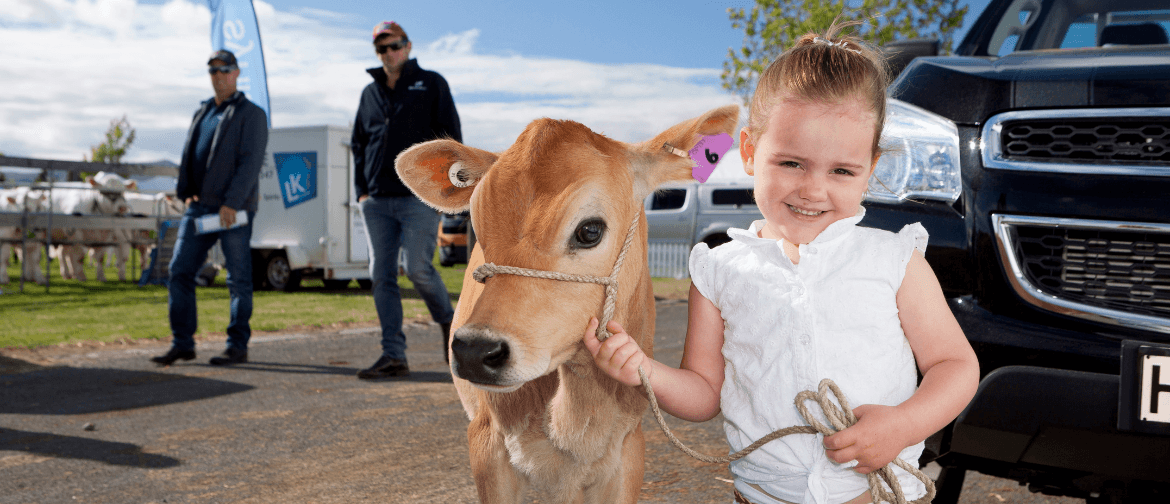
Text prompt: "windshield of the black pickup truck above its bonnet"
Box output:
[[985, 0, 1170, 56]]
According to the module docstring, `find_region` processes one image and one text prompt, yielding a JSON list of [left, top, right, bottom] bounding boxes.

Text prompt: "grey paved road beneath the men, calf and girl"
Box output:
[[0, 301, 1080, 504]]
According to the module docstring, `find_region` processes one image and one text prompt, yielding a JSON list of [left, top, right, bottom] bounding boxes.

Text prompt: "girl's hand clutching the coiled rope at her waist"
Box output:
[[825, 405, 913, 475]]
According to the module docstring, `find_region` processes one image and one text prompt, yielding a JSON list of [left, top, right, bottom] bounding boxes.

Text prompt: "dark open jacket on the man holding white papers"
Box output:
[[176, 91, 268, 214]]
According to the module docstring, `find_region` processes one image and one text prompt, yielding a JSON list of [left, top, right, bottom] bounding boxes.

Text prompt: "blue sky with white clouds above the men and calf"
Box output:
[[0, 0, 987, 161]]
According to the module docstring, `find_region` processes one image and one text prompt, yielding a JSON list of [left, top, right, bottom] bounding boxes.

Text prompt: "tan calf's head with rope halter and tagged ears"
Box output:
[[395, 105, 738, 392]]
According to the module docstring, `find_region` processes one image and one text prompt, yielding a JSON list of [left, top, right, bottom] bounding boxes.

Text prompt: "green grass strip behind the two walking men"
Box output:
[[0, 249, 690, 348]]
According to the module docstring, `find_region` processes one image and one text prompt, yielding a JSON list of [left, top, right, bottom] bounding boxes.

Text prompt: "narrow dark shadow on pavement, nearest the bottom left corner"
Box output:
[[0, 428, 181, 469]]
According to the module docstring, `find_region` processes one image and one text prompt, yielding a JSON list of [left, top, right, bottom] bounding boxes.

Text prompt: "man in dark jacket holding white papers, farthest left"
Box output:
[[151, 50, 268, 366]]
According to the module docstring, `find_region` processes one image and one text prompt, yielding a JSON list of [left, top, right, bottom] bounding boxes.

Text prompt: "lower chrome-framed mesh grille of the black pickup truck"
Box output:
[[995, 215, 1170, 332]]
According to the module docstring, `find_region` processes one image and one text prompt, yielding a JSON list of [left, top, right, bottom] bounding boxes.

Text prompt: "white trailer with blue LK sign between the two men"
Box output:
[[252, 126, 370, 290]]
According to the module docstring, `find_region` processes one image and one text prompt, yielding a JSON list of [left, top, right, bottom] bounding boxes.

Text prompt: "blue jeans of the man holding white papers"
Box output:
[[167, 201, 256, 351]]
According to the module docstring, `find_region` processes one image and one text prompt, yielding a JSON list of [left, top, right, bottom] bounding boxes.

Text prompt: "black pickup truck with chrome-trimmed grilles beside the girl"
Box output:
[[862, 0, 1170, 504]]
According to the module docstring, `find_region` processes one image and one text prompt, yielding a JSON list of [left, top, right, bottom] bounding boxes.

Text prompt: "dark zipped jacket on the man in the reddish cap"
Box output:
[[352, 58, 463, 198]]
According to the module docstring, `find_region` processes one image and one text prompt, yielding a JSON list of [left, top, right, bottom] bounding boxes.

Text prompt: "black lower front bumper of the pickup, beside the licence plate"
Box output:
[[948, 366, 1170, 491]]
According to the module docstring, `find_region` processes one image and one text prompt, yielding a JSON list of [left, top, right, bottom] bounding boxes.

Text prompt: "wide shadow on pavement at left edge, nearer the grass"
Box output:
[[0, 367, 254, 415]]
